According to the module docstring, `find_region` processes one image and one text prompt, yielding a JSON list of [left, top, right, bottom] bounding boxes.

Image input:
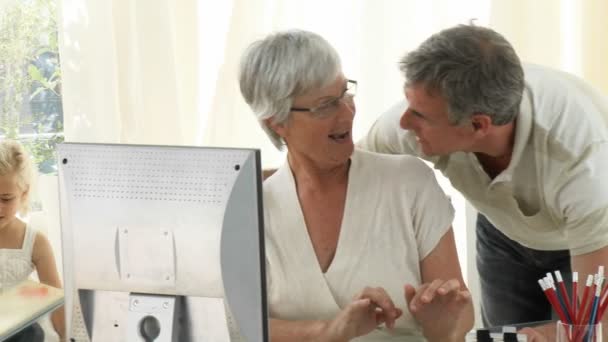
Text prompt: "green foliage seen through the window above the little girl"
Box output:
[[0, 0, 63, 173]]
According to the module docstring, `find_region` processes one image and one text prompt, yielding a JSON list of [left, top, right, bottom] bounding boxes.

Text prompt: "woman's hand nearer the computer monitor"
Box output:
[[323, 287, 403, 342]]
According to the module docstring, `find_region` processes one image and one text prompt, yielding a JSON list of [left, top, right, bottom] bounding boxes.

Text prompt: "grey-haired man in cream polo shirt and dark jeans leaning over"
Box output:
[[359, 25, 608, 336]]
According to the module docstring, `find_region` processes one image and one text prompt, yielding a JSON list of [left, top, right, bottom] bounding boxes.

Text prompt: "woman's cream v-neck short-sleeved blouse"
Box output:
[[264, 150, 454, 341]]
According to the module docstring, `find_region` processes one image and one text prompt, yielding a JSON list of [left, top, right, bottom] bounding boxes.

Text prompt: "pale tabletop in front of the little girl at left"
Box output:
[[0, 280, 63, 341]]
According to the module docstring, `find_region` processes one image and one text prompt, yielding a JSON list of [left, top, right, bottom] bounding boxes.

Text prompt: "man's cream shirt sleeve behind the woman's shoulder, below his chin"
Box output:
[[357, 100, 417, 155]]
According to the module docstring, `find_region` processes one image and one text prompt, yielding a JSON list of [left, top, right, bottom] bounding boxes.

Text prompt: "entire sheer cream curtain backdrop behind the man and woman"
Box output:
[[59, 0, 608, 328]]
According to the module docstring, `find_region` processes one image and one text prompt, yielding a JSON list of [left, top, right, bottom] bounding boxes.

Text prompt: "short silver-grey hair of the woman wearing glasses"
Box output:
[[239, 30, 342, 149]]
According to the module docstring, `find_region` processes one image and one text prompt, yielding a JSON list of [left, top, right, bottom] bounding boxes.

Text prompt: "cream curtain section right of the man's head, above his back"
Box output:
[[489, 0, 608, 94]]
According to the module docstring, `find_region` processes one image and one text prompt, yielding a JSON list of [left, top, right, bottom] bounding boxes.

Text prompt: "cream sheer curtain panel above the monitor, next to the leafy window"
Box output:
[[59, 0, 200, 144]]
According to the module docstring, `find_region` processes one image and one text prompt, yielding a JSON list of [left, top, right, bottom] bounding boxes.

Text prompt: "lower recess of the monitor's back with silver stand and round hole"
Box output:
[[73, 289, 230, 342]]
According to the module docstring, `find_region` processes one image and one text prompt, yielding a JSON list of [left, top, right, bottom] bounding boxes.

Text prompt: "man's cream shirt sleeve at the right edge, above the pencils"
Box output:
[[557, 142, 608, 255]]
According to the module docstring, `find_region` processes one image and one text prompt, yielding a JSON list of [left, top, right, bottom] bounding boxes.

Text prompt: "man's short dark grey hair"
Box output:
[[399, 25, 524, 125]]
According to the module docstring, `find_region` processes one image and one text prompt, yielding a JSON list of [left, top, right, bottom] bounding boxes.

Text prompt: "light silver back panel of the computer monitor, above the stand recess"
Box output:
[[58, 143, 267, 341]]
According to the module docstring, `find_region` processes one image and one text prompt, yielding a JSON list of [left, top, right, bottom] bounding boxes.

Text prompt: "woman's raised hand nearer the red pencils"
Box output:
[[405, 279, 472, 342]]
